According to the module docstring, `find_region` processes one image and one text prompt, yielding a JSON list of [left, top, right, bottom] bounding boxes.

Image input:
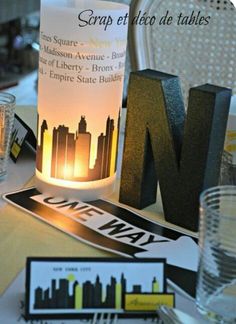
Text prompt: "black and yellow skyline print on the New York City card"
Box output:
[[33, 271, 160, 311]]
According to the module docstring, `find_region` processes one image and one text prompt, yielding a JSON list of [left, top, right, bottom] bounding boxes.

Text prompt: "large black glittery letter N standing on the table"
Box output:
[[120, 70, 231, 231]]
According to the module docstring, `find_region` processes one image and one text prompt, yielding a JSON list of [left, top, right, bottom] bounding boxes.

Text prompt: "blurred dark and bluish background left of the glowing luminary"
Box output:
[[0, 0, 40, 105]]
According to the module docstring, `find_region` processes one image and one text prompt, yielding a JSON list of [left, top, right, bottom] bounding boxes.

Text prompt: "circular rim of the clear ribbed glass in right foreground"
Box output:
[[200, 186, 236, 221]]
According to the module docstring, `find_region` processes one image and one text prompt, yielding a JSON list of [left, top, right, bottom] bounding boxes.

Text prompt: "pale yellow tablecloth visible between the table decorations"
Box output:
[[0, 106, 205, 317]]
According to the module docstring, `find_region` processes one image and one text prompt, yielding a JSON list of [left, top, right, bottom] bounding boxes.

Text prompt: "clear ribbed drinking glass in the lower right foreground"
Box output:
[[196, 186, 236, 323]]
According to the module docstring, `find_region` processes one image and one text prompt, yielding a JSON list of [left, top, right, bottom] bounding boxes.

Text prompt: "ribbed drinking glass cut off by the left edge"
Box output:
[[0, 92, 15, 179]]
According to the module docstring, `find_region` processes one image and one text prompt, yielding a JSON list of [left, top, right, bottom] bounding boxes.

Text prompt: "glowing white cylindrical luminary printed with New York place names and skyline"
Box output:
[[36, 0, 129, 201]]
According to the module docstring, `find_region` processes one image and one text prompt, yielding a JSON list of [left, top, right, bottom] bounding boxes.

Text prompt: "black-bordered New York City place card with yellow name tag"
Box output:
[[26, 258, 174, 320]]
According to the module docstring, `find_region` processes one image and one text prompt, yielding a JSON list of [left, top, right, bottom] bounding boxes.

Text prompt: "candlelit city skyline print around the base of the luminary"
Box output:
[[36, 113, 120, 182]]
